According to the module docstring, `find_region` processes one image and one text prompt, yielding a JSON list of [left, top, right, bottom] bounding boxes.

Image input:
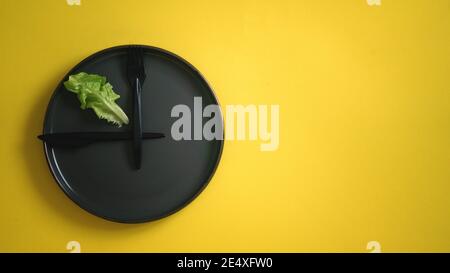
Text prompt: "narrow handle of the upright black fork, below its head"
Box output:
[[133, 78, 142, 170]]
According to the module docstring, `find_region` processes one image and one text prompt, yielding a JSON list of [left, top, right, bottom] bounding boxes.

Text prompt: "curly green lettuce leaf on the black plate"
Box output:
[[64, 72, 129, 127]]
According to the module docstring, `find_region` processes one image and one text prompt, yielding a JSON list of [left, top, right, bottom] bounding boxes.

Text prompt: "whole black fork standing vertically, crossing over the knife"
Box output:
[[127, 46, 146, 169]]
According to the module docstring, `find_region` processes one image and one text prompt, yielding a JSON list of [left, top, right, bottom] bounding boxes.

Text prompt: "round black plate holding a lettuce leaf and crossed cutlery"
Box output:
[[44, 46, 223, 223]]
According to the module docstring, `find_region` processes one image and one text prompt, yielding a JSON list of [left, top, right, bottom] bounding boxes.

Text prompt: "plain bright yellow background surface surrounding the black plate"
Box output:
[[0, 0, 450, 252]]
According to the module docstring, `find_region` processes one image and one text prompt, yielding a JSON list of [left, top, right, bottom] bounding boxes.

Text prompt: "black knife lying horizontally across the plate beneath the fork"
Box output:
[[38, 132, 164, 147]]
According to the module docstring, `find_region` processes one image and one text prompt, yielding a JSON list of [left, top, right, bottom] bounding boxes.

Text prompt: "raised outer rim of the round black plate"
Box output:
[[42, 44, 225, 224]]
